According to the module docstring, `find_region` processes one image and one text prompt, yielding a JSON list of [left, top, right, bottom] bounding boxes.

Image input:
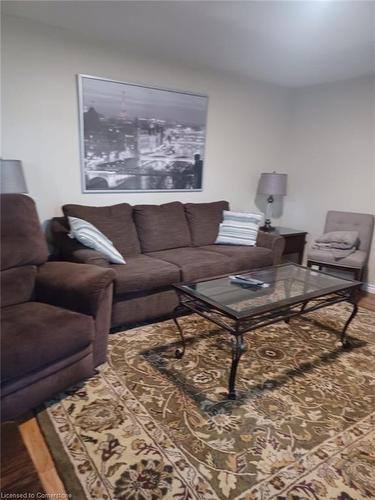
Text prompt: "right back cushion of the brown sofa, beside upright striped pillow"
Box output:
[[185, 201, 229, 247]]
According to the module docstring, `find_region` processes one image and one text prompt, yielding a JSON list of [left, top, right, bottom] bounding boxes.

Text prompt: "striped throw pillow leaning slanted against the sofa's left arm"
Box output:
[[68, 217, 126, 264]]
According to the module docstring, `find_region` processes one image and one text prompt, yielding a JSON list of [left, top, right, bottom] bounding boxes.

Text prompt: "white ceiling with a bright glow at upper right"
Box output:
[[2, 0, 375, 87]]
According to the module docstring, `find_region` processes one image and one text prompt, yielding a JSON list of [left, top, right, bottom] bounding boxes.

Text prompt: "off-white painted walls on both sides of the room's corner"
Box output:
[[2, 17, 375, 290]]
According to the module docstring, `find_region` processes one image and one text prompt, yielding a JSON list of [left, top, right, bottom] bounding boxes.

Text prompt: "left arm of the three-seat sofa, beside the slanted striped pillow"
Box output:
[[50, 217, 109, 267]]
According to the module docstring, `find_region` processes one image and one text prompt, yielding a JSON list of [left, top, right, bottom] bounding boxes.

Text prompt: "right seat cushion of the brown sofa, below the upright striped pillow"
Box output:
[[202, 245, 273, 271]]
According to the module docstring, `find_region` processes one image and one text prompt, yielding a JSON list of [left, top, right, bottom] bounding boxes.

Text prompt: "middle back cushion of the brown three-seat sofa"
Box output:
[[134, 201, 191, 253]]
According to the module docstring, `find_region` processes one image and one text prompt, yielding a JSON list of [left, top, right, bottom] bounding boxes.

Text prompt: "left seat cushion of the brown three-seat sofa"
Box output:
[[111, 255, 180, 295]]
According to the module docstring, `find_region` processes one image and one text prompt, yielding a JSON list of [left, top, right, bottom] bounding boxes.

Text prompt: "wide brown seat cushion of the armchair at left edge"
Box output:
[[1, 302, 94, 383]]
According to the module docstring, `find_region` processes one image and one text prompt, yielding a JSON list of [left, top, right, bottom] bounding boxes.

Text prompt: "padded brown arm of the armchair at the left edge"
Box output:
[[35, 262, 115, 316]]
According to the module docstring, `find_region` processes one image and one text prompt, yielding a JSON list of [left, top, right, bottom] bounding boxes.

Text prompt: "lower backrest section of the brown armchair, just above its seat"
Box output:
[[1, 266, 37, 307]]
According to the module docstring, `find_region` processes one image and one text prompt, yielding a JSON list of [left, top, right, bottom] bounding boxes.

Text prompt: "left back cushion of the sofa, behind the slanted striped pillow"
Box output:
[[63, 203, 141, 259]]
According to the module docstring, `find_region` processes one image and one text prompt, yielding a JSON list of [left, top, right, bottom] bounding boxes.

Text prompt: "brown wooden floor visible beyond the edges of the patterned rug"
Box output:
[[0, 293, 375, 498]]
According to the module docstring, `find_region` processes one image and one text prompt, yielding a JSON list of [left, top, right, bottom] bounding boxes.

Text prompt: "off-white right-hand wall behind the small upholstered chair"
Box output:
[[282, 77, 375, 292]]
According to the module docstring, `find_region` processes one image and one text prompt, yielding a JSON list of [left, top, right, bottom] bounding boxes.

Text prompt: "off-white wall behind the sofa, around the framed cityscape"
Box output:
[[3, 17, 288, 220]]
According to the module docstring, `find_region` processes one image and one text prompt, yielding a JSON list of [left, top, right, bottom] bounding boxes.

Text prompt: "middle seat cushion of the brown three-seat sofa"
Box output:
[[149, 247, 233, 281]]
